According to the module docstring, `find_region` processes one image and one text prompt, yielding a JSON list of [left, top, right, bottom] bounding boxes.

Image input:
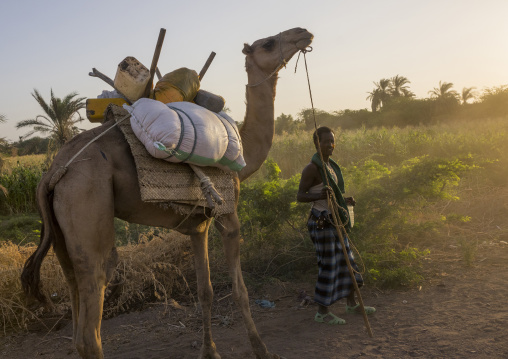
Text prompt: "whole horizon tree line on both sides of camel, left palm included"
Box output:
[[0, 79, 508, 157]]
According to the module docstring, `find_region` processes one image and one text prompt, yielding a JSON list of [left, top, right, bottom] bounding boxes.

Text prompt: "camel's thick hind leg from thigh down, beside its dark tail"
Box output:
[[54, 186, 117, 359]]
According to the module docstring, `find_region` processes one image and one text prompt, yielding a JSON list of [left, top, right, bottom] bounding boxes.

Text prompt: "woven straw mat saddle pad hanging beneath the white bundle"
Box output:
[[107, 105, 235, 216]]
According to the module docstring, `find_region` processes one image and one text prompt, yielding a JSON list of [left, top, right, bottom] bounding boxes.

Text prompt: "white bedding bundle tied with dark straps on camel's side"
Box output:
[[123, 98, 245, 171]]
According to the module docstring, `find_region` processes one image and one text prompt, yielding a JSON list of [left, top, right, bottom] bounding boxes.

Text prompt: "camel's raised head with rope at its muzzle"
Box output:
[[242, 27, 314, 80]]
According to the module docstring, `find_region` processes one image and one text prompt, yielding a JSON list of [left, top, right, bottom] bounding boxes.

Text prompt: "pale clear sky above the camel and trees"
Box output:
[[0, 0, 508, 141]]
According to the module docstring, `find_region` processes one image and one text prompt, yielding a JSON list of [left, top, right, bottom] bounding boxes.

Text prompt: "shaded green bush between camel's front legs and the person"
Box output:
[[211, 159, 315, 279]]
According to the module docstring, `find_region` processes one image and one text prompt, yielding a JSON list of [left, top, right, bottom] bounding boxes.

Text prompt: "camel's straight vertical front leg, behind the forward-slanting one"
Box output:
[[190, 220, 220, 359]]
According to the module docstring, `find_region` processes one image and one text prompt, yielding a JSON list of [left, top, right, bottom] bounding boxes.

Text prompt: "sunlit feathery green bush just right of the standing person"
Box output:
[[346, 156, 477, 287]]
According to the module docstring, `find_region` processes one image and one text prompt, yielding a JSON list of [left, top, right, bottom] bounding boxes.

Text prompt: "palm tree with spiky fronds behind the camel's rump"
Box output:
[[16, 89, 86, 149]]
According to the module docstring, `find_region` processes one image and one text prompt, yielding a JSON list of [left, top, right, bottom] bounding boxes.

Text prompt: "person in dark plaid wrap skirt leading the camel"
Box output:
[[297, 127, 376, 325]]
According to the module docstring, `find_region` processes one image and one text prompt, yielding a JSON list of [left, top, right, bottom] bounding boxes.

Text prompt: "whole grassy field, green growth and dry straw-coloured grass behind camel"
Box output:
[[0, 118, 508, 331]]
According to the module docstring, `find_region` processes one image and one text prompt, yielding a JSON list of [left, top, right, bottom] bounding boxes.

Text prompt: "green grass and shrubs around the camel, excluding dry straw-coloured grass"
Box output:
[[0, 119, 508, 287]]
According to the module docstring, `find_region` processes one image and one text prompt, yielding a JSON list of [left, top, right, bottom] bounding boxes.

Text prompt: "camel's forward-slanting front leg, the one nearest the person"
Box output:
[[215, 213, 280, 359]]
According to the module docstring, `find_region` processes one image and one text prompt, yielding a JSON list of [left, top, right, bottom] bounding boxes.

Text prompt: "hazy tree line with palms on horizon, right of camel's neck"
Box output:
[[275, 75, 508, 134]]
